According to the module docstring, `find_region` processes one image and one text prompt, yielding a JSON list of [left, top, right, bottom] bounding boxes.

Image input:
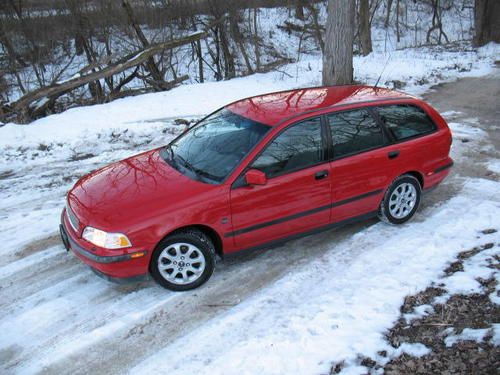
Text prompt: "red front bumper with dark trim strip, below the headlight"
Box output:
[[59, 210, 149, 281]]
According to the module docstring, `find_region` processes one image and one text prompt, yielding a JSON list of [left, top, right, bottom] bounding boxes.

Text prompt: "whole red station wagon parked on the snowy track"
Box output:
[[60, 86, 453, 290]]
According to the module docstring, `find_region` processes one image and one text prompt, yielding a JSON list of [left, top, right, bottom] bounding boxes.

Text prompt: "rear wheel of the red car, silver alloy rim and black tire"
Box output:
[[378, 174, 422, 224]]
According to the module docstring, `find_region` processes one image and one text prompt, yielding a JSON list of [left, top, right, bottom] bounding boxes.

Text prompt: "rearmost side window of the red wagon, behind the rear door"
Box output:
[[377, 105, 436, 141]]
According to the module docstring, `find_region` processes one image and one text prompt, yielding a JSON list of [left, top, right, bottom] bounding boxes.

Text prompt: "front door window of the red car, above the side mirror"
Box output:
[[251, 117, 324, 177]]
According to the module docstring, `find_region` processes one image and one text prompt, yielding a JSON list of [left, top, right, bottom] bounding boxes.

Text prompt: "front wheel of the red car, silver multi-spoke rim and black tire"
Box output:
[[149, 229, 216, 292]]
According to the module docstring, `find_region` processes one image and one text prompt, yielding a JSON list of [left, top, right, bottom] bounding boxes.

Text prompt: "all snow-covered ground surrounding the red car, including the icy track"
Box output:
[[0, 40, 500, 374]]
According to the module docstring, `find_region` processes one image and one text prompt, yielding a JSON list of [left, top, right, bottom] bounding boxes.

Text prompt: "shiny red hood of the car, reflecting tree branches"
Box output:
[[68, 149, 217, 230]]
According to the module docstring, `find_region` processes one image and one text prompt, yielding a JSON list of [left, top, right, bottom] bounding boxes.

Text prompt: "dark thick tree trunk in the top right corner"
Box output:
[[473, 0, 500, 46]]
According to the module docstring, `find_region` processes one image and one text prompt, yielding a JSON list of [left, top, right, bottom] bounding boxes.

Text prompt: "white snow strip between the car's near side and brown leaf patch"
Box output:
[[131, 180, 500, 374]]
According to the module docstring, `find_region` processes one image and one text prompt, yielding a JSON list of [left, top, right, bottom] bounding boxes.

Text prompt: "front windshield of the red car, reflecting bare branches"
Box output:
[[161, 109, 270, 184]]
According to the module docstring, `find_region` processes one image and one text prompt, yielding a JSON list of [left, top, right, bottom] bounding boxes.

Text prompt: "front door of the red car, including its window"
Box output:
[[226, 117, 331, 248]]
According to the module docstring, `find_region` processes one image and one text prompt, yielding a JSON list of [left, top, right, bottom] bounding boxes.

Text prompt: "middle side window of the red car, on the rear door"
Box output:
[[327, 109, 385, 158]]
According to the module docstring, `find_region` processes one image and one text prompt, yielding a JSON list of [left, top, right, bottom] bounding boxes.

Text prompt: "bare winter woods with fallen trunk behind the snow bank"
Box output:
[[0, 0, 500, 122]]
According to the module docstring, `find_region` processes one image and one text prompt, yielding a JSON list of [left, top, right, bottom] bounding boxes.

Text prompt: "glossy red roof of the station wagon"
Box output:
[[225, 85, 415, 126]]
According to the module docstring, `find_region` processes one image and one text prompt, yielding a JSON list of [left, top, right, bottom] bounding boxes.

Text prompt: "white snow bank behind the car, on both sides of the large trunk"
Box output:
[[0, 43, 500, 150]]
